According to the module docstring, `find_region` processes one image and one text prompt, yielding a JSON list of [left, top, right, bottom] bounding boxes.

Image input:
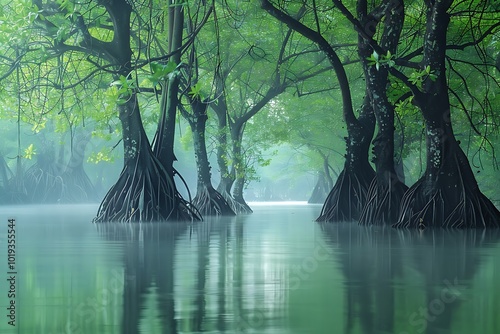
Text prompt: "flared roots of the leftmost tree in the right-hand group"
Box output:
[[316, 168, 374, 222]]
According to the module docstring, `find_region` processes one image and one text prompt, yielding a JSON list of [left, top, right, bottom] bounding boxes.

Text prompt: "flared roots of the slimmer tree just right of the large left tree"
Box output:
[[193, 186, 236, 216]]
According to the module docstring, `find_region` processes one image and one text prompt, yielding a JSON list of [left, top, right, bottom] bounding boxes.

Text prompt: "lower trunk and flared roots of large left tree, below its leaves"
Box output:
[[94, 93, 200, 222]]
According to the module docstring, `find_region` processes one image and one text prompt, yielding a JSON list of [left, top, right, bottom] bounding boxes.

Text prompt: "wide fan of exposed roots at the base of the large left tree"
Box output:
[[94, 157, 201, 222]]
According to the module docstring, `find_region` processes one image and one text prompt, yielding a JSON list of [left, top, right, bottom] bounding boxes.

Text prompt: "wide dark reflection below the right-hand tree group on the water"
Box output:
[[321, 223, 500, 334]]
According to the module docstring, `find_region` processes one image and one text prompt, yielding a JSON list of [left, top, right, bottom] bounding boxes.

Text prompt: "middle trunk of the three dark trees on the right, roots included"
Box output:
[[358, 0, 408, 225]]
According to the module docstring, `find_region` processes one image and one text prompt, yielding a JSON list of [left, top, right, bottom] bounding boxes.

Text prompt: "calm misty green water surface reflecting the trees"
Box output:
[[0, 203, 500, 334]]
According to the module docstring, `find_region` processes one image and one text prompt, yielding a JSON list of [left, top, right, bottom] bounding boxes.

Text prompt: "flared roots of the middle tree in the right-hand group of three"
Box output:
[[359, 173, 408, 225]]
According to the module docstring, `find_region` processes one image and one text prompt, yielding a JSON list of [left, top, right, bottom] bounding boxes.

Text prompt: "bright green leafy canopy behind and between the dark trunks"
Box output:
[[0, 0, 500, 201]]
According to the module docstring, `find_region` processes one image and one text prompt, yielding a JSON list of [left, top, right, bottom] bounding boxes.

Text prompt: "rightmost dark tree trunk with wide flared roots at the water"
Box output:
[[394, 0, 500, 229]]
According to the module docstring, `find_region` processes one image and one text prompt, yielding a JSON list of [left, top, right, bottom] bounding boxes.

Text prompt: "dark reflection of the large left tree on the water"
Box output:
[[96, 223, 188, 334]]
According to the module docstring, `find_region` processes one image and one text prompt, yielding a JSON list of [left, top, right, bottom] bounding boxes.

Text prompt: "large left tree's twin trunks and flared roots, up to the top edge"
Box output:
[[94, 0, 201, 222]]
